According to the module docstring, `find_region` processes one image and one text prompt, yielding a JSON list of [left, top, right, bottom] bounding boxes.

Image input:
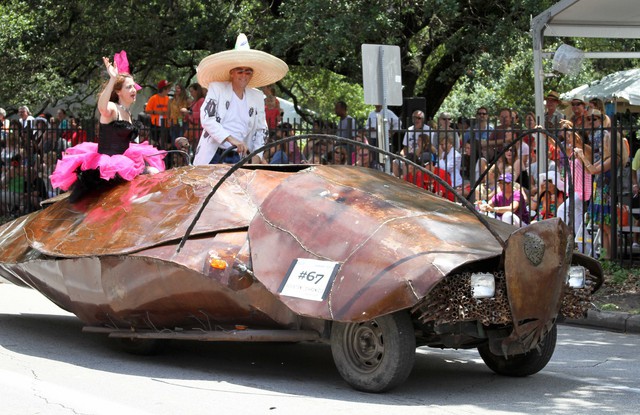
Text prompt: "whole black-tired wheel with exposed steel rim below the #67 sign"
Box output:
[[331, 311, 416, 392]]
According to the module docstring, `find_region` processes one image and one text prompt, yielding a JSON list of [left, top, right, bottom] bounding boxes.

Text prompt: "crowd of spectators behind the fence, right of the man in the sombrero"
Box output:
[[258, 91, 640, 257]]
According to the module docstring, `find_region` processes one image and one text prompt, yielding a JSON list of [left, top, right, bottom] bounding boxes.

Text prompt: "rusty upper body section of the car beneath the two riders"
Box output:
[[24, 165, 288, 257]]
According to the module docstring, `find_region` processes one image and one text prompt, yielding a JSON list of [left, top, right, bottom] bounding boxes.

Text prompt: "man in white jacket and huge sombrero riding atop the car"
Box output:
[[193, 33, 289, 165]]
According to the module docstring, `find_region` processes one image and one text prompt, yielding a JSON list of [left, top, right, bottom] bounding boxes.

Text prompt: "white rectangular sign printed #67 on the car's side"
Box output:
[[278, 258, 340, 301]]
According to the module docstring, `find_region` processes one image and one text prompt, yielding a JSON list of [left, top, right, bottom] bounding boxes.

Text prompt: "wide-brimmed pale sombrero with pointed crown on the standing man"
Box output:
[[196, 33, 289, 88]]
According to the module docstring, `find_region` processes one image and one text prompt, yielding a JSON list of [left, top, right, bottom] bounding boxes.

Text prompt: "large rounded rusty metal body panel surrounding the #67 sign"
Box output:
[[249, 166, 514, 321]]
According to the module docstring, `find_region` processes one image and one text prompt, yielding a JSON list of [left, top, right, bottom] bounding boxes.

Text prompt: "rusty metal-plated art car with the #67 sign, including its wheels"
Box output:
[[0, 157, 602, 392]]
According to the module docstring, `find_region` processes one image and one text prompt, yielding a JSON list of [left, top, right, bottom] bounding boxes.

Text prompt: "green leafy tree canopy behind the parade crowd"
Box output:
[[0, 0, 636, 122]]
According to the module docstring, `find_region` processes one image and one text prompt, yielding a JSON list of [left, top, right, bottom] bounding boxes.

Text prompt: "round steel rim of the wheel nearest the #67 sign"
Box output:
[[344, 320, 384, 373]]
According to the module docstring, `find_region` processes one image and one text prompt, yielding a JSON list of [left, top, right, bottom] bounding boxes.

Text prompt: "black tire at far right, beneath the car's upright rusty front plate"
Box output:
[[478, 324, 558, 377]]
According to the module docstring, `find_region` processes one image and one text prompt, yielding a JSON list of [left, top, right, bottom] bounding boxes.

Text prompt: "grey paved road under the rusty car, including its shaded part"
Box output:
[[0, 284, 640, 415]]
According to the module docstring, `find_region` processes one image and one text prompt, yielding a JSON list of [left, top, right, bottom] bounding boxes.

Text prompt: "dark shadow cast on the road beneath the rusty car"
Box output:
[[0, 314, 632, 414]]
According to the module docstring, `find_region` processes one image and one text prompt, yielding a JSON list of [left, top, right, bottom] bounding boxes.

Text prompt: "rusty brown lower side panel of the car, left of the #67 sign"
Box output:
[[2, 226, 301, 330]]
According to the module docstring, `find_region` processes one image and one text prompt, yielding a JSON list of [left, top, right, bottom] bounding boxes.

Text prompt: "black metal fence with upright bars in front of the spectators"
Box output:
[[0, 118, 640, 264]]
